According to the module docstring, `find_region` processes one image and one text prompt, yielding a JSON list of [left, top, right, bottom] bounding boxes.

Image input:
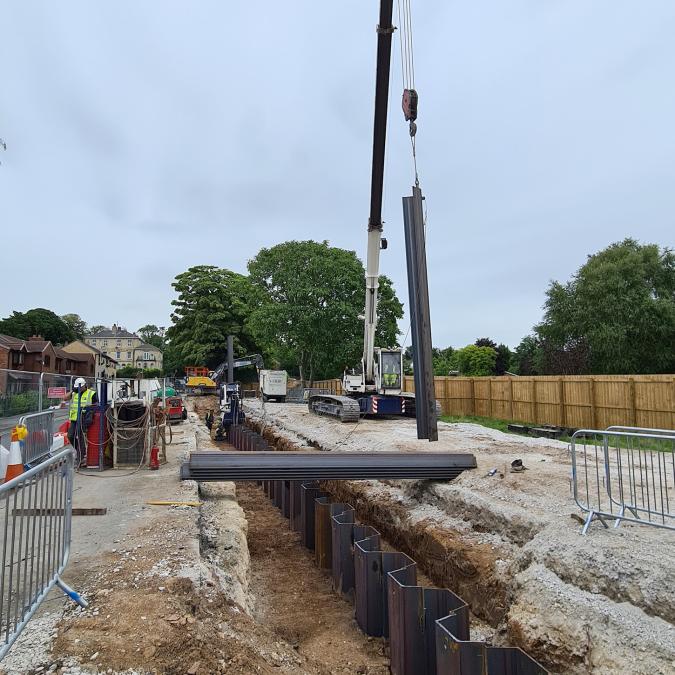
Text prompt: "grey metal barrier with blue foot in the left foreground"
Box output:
[[0, 448, 87, 659]]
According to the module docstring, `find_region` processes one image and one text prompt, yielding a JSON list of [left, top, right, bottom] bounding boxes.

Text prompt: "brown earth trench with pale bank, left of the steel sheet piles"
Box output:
[[193, 420, 389, 675]]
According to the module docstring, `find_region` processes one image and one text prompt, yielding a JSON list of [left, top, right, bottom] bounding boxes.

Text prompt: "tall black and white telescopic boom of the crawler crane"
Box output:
[[363, 0, 394, 383]]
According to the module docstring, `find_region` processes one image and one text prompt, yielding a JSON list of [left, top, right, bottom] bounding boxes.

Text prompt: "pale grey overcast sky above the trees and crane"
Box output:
[[0, 0, 675, 347]]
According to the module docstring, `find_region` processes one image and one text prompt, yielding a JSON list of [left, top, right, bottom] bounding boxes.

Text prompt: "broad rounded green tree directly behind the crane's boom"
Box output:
[[248, 241, 403, 380]]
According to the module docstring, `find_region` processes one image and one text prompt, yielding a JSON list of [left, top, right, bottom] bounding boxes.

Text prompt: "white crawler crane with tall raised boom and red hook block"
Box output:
[[308, 0, 417, 422]]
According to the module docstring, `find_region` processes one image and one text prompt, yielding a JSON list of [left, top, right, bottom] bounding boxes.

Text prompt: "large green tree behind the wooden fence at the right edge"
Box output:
[[535, 239, 675, 374]]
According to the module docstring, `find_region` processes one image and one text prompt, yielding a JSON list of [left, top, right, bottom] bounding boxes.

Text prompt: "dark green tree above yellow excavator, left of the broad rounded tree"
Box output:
[[165, 265, 258, 373]]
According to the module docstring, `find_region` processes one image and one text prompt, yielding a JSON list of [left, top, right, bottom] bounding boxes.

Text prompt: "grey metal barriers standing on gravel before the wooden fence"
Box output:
[[570, 427, 675, 534]]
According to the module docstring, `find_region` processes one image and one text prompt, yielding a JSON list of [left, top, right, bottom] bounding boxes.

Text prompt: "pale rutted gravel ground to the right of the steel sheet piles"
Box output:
[[246, 401, 675, 675]]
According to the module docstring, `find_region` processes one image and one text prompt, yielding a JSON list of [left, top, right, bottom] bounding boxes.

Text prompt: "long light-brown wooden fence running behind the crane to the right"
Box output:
[[314, 375, 675, 429]]
